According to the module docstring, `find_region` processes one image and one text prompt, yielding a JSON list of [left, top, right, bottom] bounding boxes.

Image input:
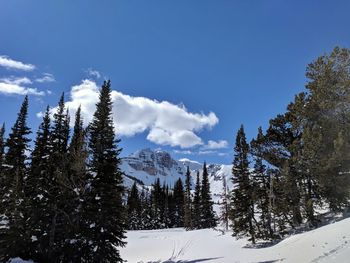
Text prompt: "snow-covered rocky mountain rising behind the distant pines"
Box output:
[[121, 148, 232, 202]]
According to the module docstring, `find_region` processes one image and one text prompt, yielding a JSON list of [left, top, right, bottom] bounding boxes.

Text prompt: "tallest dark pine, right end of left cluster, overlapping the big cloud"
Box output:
[[83, 81, 126, 262]]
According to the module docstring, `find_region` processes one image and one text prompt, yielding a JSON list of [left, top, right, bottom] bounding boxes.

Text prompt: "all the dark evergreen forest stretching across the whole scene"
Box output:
[[0, 47, 350, 262]]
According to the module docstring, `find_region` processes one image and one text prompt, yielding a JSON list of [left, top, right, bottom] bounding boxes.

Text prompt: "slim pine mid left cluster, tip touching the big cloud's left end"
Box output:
[[45, 94, 72, 262]]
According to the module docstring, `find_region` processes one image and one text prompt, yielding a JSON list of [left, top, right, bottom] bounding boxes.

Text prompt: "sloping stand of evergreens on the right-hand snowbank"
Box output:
[[229, 47, 350, 243]]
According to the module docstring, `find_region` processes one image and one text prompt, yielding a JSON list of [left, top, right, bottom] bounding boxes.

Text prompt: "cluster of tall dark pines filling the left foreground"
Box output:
[[0, 81, 126, 262]]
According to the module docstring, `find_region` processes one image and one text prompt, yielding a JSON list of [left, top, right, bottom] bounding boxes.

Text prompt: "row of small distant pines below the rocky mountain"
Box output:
[[126, 163, 217, 230]]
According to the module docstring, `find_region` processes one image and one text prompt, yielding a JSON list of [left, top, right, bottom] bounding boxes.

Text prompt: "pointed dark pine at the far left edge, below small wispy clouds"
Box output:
[[0, 96, 31, 262]]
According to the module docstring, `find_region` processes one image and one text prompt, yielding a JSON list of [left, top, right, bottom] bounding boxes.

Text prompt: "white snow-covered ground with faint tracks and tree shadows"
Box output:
[[121, 218, 350, 263]]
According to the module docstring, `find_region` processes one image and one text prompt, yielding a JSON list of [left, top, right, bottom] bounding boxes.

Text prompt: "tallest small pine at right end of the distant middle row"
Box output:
[[200, 162, 216, 228]]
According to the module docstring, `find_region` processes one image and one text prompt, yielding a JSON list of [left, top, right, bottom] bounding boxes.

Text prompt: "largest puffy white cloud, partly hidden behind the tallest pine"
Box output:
[[57, 79, 219, 148]]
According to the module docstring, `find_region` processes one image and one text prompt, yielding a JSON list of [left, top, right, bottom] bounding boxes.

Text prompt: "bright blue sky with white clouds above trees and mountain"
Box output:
[[0, 0, 350, 163]]
